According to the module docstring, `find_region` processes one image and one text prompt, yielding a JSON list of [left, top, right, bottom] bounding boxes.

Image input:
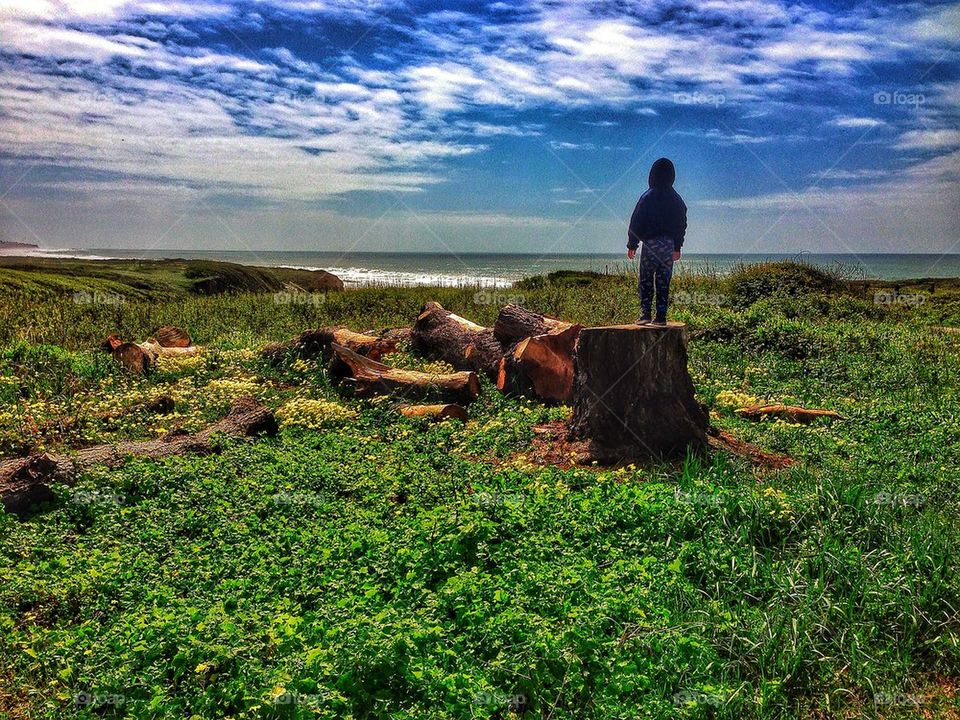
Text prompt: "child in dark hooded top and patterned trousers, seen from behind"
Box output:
[[627, 158, 687, 325]]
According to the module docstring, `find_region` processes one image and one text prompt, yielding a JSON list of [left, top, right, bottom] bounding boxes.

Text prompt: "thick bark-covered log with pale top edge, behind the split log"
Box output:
[[410, 301, 503, 378]]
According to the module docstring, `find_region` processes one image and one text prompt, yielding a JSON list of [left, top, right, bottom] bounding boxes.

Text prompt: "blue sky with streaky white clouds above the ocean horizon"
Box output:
[[0, 0, 960, 254]]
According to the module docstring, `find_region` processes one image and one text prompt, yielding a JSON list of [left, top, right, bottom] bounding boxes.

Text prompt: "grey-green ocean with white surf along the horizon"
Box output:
[[7, 249, 960, 288]]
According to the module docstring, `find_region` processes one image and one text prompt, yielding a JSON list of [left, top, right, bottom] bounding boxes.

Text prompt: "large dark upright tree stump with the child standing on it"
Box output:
[[570, 322, 708, 461]]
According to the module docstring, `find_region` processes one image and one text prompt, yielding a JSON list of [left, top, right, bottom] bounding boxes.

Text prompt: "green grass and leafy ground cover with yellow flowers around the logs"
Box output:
[[0, 265, 960, 720]]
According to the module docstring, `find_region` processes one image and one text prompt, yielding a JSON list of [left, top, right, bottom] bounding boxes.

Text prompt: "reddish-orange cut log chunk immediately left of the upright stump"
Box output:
[[497, 325, 581, 402]]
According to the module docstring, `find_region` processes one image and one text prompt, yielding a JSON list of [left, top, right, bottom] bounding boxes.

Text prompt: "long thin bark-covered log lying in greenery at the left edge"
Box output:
[[0, 397, 277, 514]]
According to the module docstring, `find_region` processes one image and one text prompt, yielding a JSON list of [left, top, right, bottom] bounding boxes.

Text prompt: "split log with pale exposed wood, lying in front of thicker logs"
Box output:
[[330, 343, 480, 403]]
